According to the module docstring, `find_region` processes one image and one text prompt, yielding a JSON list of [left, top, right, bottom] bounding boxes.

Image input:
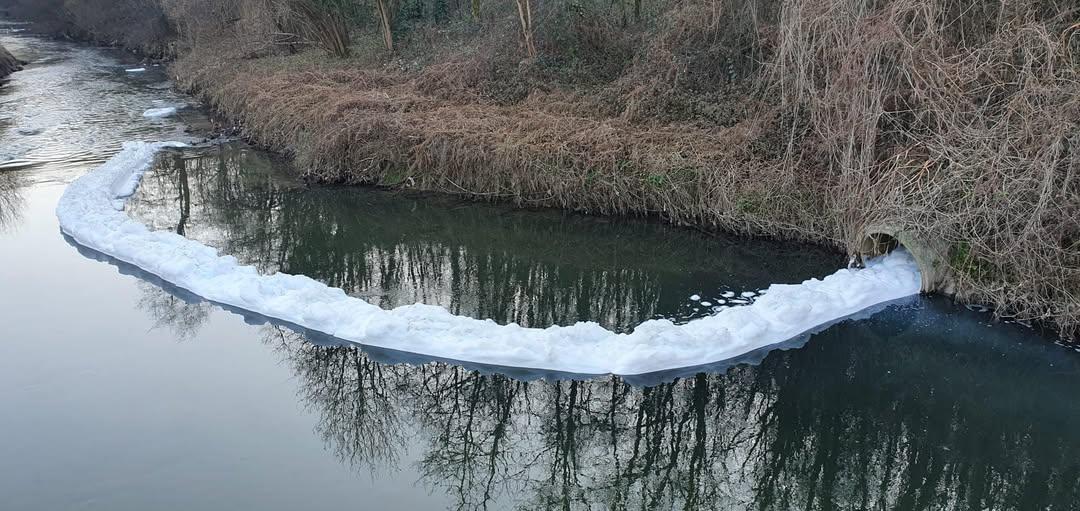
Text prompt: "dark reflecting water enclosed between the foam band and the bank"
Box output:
[[130, 141, 840, 331]]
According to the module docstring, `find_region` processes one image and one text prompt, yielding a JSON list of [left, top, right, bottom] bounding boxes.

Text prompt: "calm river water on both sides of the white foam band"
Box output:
[[0, 25, 1080, 510]]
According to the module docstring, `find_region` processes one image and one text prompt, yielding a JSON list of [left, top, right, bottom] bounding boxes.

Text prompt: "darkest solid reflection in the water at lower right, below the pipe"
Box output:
[[756, 323, 1080, 509]]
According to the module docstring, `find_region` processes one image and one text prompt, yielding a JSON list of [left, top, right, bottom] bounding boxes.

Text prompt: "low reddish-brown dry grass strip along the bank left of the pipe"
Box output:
[[178, 47, 828, 241]]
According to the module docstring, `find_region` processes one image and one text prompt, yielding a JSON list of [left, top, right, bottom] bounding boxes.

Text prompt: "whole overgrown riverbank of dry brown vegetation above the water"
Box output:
[[2, 0, 1080, 335]]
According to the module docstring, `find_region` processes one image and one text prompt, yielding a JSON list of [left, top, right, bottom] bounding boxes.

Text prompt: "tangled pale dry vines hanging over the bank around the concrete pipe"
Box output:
[[769, 0, 1080, 335]]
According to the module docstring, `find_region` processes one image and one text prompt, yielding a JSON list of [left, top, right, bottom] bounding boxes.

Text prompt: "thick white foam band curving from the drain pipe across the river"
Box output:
[[56, 143, 919, 375]]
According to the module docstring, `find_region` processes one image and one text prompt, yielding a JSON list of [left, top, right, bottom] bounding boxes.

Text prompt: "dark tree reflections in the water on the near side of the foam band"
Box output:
[[248, 304, 1080, 510]]
